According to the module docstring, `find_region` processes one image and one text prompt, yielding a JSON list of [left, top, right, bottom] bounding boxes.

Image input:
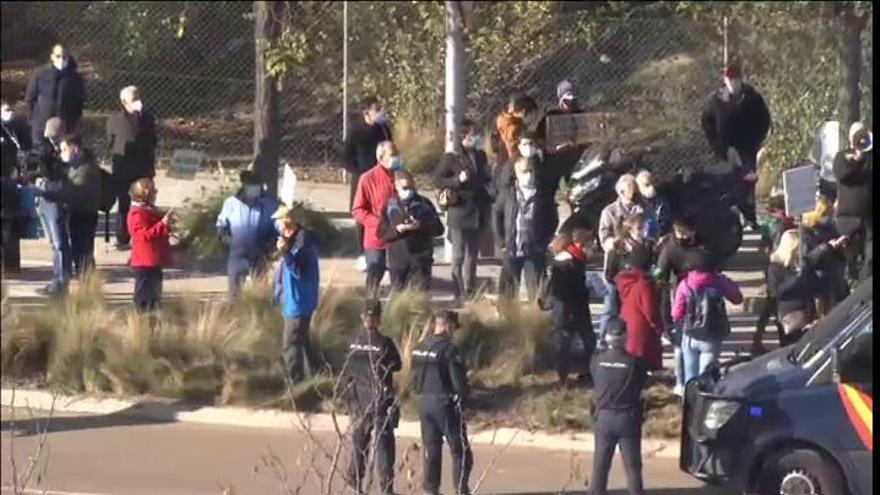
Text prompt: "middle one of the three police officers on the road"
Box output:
[[412, 311, 474, 495]]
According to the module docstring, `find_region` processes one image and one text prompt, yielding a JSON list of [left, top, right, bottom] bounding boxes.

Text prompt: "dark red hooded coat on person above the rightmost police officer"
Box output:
[[615, 268, 663, 370]]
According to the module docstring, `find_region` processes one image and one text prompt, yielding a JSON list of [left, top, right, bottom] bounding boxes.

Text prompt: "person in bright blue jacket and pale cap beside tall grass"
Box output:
[[272, 206, 321, 384]]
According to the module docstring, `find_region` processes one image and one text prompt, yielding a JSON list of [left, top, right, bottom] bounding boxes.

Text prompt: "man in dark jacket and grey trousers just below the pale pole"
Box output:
[[435, 119, 492, 299]]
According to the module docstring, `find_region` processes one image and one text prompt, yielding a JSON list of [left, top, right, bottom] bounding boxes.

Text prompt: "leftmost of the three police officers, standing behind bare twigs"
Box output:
[[344, 300, 401, 494]]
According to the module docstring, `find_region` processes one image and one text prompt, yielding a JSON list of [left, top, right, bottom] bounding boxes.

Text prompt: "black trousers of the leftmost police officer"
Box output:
[[346, 401, 397, 494]]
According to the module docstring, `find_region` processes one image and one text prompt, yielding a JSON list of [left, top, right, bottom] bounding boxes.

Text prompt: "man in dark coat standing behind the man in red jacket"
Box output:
[[343, 96, 391, 271]]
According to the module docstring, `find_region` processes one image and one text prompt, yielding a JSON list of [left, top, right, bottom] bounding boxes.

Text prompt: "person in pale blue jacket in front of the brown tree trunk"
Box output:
[[217, 170, 278, 299]]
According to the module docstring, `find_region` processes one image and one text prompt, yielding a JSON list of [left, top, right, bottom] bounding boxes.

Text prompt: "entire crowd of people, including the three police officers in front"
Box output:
[[2, 44, 873, 494]]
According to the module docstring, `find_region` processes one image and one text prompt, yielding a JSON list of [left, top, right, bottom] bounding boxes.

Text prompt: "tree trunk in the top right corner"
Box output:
[[835, 2, 865, 138]]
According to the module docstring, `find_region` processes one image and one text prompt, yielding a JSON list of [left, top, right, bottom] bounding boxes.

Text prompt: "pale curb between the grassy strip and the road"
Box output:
[[0, 388, 680, 459]]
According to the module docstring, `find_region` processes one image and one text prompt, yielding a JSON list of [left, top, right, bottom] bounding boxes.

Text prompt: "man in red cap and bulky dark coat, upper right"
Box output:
[[701, 64, 770, 228]]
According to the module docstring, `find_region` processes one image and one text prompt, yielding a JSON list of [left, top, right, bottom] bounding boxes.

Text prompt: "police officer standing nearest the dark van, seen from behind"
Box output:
[[590, 318, 647, 495]]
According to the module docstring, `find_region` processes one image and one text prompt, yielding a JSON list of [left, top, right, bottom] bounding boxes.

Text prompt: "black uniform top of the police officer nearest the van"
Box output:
[[590, 348, 647, 411]]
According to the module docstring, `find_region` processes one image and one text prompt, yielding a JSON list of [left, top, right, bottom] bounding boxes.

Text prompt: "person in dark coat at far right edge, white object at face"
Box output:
[[833, 122, 874, 280]]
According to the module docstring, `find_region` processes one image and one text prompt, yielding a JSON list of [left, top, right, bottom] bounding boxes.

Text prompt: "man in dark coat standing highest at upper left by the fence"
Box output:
[[25, 43, 86, 143]]
